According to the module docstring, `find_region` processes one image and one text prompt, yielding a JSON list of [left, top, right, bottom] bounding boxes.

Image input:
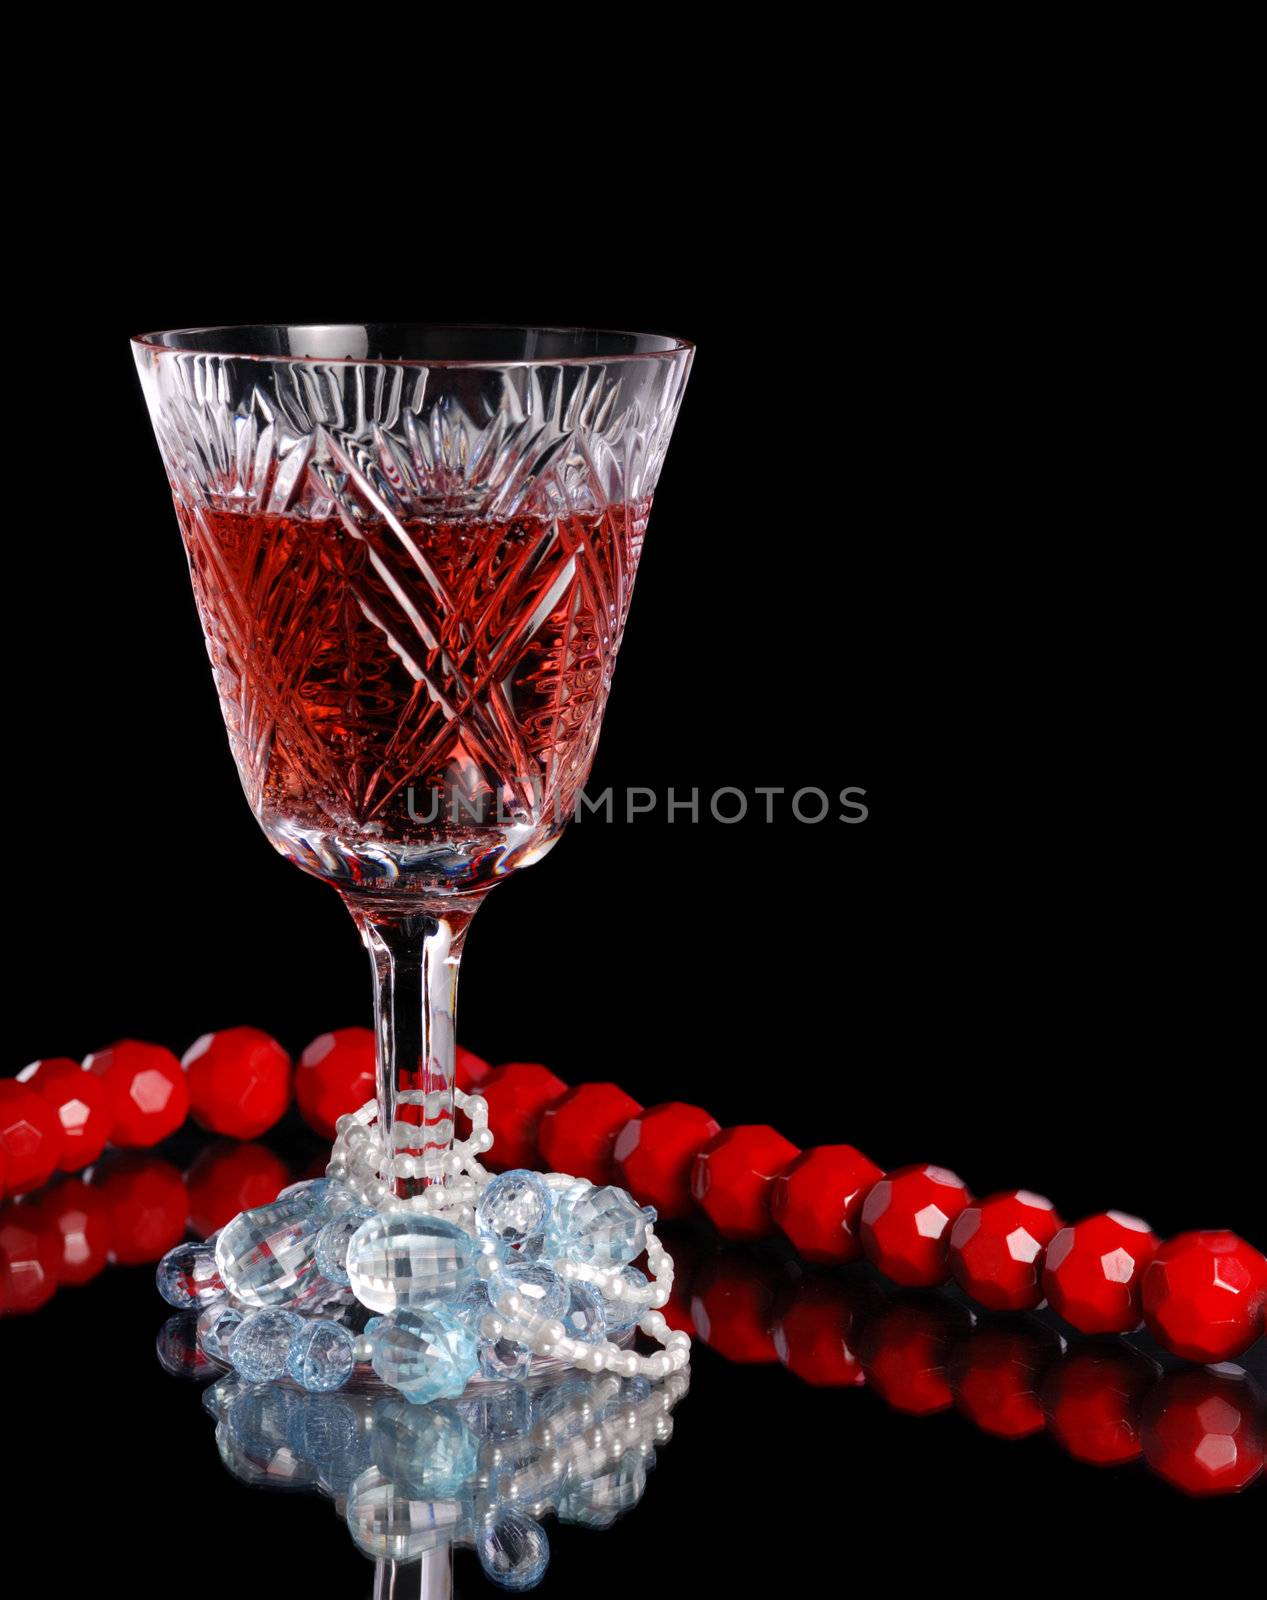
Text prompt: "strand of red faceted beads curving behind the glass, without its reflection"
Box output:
[[0, 1027, 1267, 1362]]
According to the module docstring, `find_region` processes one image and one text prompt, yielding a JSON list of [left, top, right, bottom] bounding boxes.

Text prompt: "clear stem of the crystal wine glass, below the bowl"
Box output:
[[349, 896, 480, 1200]]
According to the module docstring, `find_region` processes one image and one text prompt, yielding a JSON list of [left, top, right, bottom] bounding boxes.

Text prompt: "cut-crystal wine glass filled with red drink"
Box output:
[[133, 323, 693, 1197]]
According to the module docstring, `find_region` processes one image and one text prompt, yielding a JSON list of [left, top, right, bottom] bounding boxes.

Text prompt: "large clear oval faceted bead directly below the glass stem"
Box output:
[[346, 1211, 478, 1314]]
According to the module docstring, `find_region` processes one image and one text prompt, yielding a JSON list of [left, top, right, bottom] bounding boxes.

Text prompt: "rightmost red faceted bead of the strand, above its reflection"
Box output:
[[1142, 1229, 1267, 1362]]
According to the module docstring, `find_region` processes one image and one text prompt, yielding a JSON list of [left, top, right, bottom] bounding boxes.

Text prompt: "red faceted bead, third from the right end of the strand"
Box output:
[[947, 1189, 1064, 1310]]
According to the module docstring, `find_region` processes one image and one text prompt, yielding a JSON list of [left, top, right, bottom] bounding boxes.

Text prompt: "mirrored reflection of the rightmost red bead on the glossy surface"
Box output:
[[1141, 1368, 1264, 1494]]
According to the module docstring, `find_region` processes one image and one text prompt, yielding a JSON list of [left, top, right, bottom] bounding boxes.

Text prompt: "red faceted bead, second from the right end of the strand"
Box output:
[[1041, 1211, 1158, 1333]]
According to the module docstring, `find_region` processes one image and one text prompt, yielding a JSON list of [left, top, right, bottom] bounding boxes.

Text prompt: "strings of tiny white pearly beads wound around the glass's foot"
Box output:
[[326, 1090, 691, 1379]]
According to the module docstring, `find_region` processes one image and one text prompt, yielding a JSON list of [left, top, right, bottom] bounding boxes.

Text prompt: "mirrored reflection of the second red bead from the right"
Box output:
[[1043, 1344, 1158, 1467]]
